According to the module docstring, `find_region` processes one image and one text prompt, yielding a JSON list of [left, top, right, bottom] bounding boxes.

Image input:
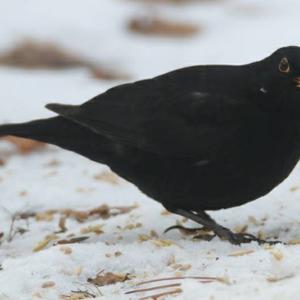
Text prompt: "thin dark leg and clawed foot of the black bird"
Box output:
[[166, 206, 277, 245]]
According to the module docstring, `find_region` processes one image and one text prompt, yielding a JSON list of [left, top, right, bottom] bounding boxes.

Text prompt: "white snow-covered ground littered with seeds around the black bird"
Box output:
[[0, 0, 300, 300]]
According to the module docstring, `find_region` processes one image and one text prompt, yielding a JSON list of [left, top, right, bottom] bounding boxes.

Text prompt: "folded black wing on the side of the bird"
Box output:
[[47, 80, 258, 157]]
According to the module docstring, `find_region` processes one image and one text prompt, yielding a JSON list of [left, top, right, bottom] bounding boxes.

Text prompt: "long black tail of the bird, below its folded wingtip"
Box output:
[[0, 116, 113, 163]]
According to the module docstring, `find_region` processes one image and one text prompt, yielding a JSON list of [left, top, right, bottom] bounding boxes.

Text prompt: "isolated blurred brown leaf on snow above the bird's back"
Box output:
[[128, 16, 200, 37]]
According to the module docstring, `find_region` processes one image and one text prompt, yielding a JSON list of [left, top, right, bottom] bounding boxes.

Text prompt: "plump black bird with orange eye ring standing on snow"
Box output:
[[0, 46, 300, 244]]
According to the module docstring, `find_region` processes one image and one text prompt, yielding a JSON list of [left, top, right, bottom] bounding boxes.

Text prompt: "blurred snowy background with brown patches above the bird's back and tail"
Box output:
[[0, 0, 300, 122]]
